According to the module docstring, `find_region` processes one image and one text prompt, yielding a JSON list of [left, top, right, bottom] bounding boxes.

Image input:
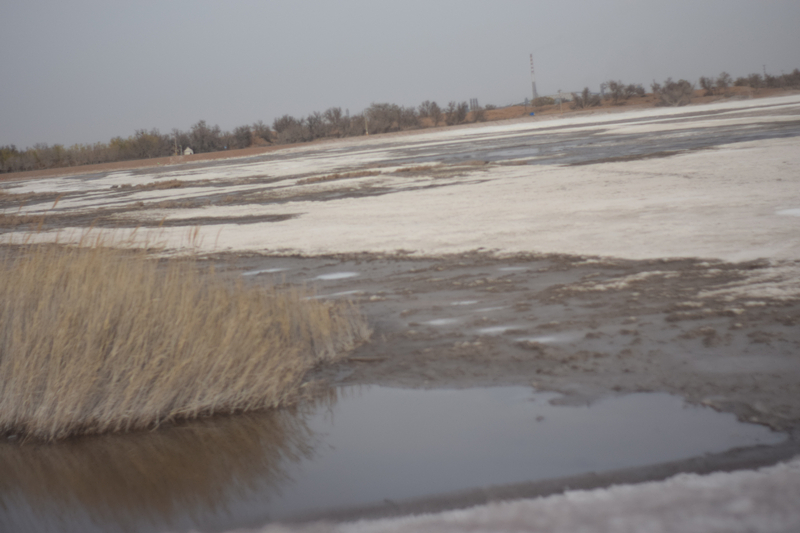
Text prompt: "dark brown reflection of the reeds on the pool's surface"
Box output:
[[0, 391, 336, 532]]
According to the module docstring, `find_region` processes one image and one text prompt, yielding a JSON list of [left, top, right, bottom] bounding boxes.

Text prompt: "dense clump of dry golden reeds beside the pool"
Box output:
[[0, 245, 369, 440]]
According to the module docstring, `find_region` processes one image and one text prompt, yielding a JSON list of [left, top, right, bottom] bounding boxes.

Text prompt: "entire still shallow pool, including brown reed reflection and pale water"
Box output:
[[0, 387, 785, 531]]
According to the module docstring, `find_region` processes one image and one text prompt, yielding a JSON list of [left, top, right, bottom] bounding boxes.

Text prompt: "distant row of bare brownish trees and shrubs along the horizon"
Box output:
[[0, 69, 800, 173]]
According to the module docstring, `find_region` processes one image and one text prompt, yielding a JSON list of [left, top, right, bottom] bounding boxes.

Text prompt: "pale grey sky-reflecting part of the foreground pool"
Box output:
[[269, 387, 785, 519]]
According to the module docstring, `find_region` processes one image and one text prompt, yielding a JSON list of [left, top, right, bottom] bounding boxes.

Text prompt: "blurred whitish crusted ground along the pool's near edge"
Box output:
[[262, 457, 800, 533]]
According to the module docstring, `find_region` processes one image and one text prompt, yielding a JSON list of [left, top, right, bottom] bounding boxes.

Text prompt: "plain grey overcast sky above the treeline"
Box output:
[[0, 0, 800, 148]]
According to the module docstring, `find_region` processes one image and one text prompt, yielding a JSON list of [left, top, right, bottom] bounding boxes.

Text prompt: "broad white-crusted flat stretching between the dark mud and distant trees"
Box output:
[[3, 96, 800, 268]]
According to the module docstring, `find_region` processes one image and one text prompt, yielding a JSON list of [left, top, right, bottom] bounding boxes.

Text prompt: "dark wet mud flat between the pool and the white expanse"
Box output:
[[219, 253, 800, 430]]
